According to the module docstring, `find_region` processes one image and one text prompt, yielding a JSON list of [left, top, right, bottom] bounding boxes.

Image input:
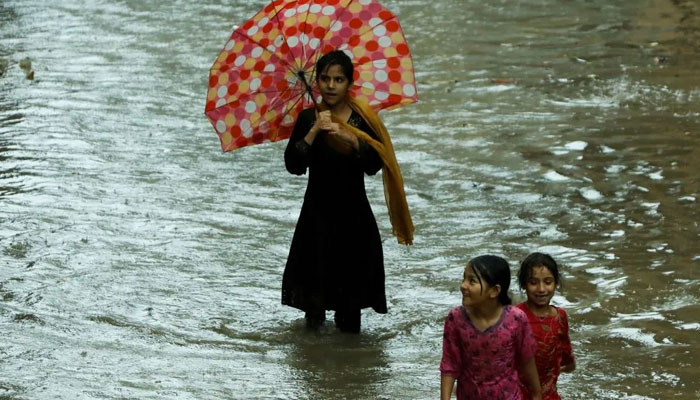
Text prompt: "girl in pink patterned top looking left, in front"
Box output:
[[440, 255, 542, 400]]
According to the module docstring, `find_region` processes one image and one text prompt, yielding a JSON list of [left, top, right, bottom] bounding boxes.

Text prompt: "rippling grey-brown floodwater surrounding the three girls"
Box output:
[[0, 0, 700, 400]]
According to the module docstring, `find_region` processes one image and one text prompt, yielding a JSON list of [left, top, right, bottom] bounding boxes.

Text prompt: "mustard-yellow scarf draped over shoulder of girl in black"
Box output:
[[319, 96, 415, 245]]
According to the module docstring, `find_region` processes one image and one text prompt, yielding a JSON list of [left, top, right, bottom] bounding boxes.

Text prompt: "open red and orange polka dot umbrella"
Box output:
[[205, 0, 418, 151]]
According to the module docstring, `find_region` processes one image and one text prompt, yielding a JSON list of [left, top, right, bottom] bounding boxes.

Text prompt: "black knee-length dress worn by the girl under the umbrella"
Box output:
[[282, 109, 387, 313]]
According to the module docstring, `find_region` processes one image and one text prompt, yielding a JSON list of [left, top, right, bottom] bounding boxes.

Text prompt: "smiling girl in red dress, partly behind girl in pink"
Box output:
[[518, 253, 576, 400]]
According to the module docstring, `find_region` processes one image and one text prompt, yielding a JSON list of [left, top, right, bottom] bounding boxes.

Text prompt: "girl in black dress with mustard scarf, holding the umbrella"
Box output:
[[282, 50, 413, 333]]
